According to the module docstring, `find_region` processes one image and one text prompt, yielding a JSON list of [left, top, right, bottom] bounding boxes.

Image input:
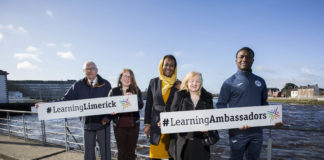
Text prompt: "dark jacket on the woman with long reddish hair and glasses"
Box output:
[[109, 87, 144, 126]]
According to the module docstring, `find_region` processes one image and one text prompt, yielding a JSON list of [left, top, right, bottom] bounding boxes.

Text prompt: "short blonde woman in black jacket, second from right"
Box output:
[[169, 72, 213, 160]]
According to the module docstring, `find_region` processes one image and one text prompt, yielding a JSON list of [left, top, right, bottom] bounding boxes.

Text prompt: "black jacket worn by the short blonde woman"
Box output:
[[169, 88, 213, 160]]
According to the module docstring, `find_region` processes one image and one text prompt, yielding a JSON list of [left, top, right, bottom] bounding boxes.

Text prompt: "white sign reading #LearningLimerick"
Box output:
[[38, 95, 138, 120]]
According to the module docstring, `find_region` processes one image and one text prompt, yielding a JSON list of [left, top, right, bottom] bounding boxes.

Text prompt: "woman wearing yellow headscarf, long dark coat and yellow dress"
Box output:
[[144, 55, 181, 159]]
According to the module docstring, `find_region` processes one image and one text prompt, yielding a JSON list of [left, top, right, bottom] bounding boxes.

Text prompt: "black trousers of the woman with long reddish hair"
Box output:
[[114, 123, 140, 160]]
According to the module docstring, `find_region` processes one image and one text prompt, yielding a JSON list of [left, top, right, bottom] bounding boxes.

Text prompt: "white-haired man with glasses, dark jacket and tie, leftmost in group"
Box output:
[[63, 61, 111, 160]]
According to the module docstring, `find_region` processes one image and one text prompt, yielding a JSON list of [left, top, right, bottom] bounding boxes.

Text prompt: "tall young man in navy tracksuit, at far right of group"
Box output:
[[216, 47, 281, 160]]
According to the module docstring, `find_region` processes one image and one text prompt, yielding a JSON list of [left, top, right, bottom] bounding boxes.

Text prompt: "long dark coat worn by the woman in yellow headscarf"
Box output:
[[144, 77, 178, 145]]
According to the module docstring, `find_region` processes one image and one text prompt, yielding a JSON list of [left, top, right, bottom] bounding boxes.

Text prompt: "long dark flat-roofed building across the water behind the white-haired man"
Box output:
[[8, 80, 76, 101]]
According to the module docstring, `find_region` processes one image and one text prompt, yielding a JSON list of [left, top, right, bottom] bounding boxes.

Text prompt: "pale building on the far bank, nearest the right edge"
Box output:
[[298, 84, 323, 98]]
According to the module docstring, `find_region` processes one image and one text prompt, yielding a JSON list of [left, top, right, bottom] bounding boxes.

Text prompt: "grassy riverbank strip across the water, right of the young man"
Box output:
[[268, 97, 324, 105]]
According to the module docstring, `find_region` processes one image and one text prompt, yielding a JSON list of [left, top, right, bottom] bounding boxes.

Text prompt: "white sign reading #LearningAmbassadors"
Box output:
[[160, 105, 282, 134]]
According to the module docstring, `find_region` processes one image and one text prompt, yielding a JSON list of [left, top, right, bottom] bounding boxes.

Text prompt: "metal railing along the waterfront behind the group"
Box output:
[[0, 109, 324, 160]]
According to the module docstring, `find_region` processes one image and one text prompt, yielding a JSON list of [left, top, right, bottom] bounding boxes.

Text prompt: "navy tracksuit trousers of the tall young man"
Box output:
[[229, 132, 263, 160]]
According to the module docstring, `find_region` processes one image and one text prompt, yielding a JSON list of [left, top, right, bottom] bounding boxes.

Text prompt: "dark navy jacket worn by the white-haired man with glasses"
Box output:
[[62, 75, 111, 130]]
